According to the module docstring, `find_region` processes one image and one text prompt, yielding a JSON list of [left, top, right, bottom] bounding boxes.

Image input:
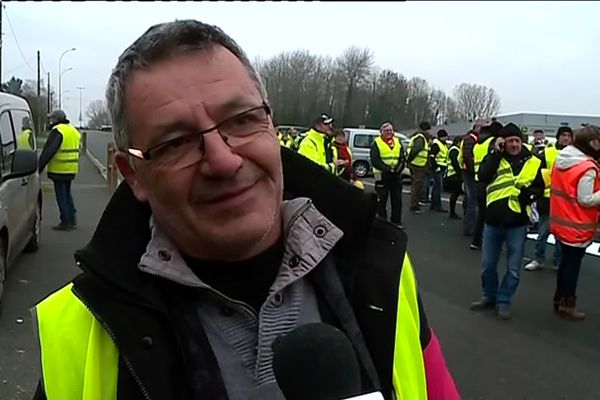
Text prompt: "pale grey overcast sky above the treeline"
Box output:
[[2, 1, 600, 121]]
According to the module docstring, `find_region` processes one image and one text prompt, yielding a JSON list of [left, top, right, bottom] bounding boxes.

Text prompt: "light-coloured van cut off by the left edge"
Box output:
[[0, 93, 42, 311]]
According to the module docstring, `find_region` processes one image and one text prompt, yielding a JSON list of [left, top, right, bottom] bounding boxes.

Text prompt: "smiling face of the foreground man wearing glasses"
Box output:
[[118, 46, 283, 261]]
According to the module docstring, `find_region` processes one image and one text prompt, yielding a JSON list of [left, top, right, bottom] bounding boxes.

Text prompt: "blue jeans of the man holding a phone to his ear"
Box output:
[[481, 224, 527, 306]]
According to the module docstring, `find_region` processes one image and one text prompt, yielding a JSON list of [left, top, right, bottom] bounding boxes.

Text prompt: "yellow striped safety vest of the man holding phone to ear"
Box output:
[[486, 156, 542, 214]]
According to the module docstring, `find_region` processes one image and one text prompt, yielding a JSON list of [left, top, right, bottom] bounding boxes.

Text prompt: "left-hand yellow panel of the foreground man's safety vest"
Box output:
[[36, 283, 119, 400]]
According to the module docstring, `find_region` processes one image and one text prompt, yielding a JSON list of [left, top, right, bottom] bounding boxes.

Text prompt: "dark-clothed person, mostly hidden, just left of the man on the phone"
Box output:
[[458, 123, 482, 236]]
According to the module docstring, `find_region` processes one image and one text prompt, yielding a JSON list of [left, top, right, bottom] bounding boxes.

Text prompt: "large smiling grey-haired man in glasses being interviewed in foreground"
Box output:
[[35, 20, 458, 400]]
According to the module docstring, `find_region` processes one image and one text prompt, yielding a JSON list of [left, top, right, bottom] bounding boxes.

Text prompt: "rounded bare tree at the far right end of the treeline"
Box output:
[[454, 83, 500, 121]]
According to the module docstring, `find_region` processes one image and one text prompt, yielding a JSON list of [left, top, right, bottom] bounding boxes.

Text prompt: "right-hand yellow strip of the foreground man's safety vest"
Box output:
[[392, 254, 427, 400]]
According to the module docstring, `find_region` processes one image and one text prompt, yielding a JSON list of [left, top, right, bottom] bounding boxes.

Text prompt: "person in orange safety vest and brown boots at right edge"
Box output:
[[550, 126, 600, 321]]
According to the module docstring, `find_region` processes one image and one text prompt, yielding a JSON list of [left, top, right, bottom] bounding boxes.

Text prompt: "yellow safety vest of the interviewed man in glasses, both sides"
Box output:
[[36, 254, 427, 400]]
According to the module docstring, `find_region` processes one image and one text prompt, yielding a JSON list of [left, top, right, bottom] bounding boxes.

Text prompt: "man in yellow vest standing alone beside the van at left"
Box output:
[[39, 110, 81, 231]]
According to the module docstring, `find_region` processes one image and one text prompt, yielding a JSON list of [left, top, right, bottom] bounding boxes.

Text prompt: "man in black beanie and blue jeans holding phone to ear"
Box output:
[[471, 123, 544, 320]]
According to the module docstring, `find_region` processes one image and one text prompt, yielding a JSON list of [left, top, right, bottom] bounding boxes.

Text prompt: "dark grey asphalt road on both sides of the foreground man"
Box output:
[[0, 134, 600, 400]]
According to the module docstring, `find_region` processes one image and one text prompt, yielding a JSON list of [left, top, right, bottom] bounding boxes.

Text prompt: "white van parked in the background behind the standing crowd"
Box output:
[[344, 128, 410, 178]]
